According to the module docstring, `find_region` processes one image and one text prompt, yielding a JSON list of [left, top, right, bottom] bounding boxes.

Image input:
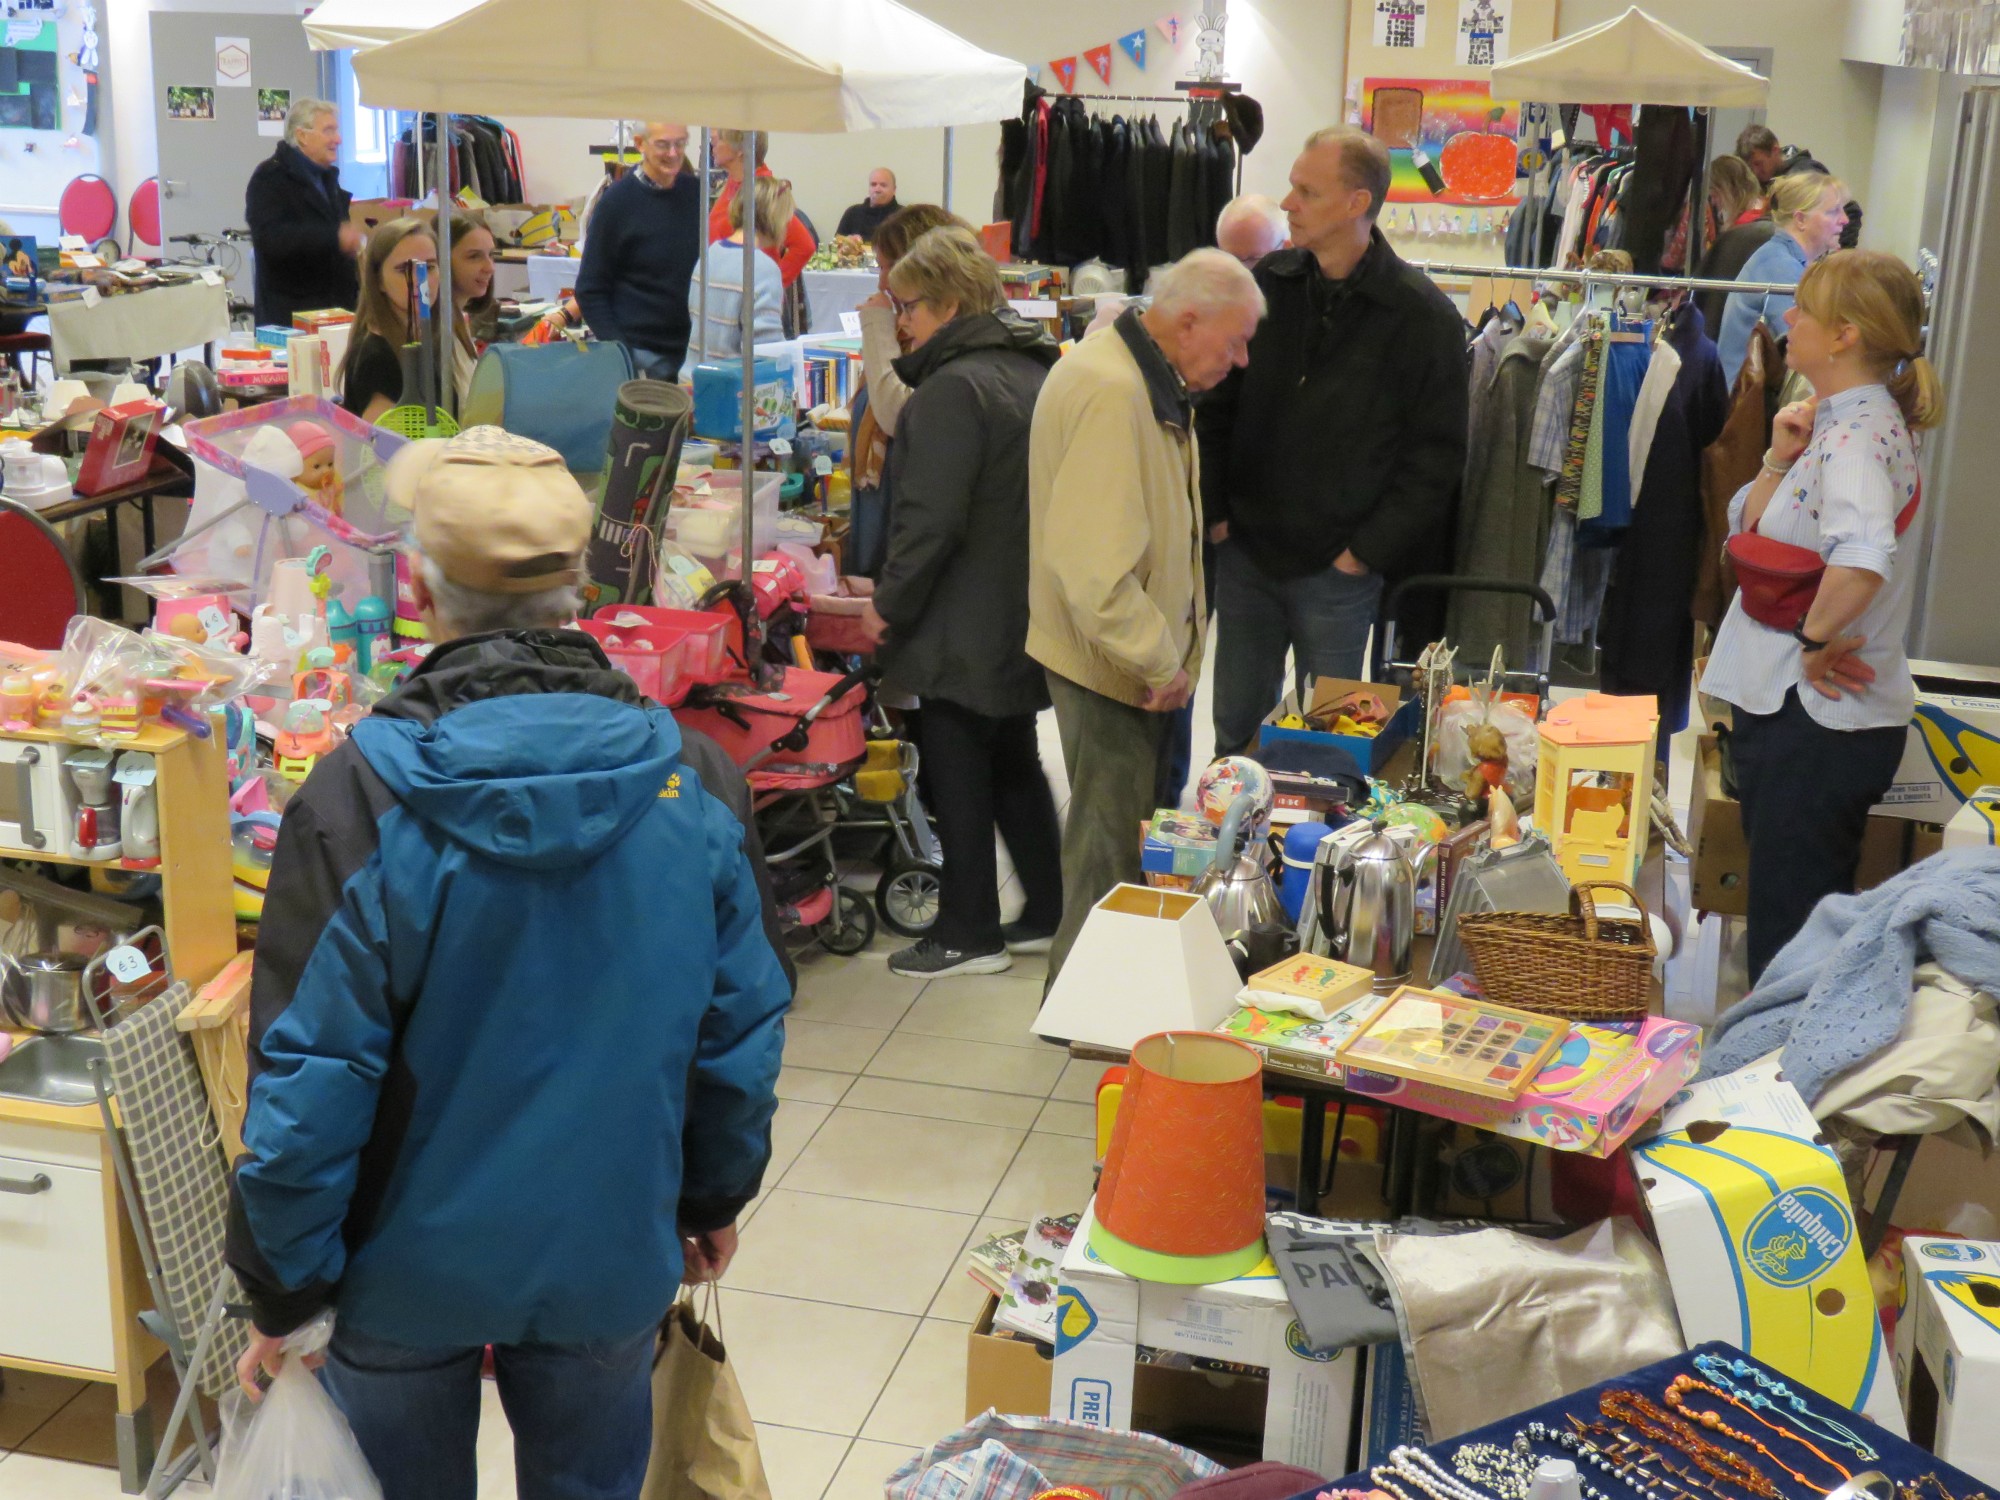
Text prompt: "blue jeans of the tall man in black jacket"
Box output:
[[1216, 542, 1382, 756]]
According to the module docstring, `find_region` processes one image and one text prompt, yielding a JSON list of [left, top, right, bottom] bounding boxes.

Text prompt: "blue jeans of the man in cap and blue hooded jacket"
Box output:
[[320, 1322, 656, 1500]]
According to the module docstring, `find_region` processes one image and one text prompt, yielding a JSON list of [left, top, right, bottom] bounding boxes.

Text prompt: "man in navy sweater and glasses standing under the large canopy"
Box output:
[[576, 122, 702, 380]]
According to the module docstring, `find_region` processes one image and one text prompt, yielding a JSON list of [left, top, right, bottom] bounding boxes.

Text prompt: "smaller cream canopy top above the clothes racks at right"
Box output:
[[1492, 6, 1770, 110]]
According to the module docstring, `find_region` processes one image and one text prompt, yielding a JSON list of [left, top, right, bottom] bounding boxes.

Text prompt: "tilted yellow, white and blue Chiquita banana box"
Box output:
[[1632, 1058, 1904, 1436]]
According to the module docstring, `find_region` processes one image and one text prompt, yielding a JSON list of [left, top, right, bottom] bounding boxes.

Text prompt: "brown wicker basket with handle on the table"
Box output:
[[1458, 880, 1654, 1022]]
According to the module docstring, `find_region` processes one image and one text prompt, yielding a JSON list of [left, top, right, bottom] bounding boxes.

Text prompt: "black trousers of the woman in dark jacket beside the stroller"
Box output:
[[918, 696, 1062, 954]]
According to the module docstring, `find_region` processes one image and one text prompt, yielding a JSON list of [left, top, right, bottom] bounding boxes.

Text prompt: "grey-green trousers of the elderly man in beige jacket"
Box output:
[[1048, 672, 1174, 984]]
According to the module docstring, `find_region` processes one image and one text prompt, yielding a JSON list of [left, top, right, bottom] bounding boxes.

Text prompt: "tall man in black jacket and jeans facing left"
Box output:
[[1196, 126, 1466, 754]]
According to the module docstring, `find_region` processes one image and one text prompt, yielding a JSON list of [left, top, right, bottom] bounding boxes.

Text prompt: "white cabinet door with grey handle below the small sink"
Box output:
[[0, 1122, 116, 1370]]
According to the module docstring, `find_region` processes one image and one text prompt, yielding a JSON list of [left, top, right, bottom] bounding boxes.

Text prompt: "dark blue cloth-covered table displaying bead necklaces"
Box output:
[[1298, 1342, 2000, 1500]]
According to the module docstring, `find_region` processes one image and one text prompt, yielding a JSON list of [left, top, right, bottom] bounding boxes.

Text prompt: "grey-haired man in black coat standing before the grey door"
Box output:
[[244, 98, 362, 328]]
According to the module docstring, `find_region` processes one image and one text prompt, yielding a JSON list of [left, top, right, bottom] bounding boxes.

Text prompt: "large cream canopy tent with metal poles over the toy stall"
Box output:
[[328, 0, 1028, 576]]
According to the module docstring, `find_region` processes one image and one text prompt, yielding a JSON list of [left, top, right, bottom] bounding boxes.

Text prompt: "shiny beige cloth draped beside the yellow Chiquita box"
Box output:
[[1376, 1218, 1682, 1442]]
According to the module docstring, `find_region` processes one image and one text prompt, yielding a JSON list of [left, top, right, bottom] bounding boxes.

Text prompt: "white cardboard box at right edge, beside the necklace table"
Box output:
[[1896, 1234, 2000, 1484]]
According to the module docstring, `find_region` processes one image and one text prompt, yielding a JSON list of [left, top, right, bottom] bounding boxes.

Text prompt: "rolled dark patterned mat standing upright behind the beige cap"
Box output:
[[584, 380, 692, 614]]
